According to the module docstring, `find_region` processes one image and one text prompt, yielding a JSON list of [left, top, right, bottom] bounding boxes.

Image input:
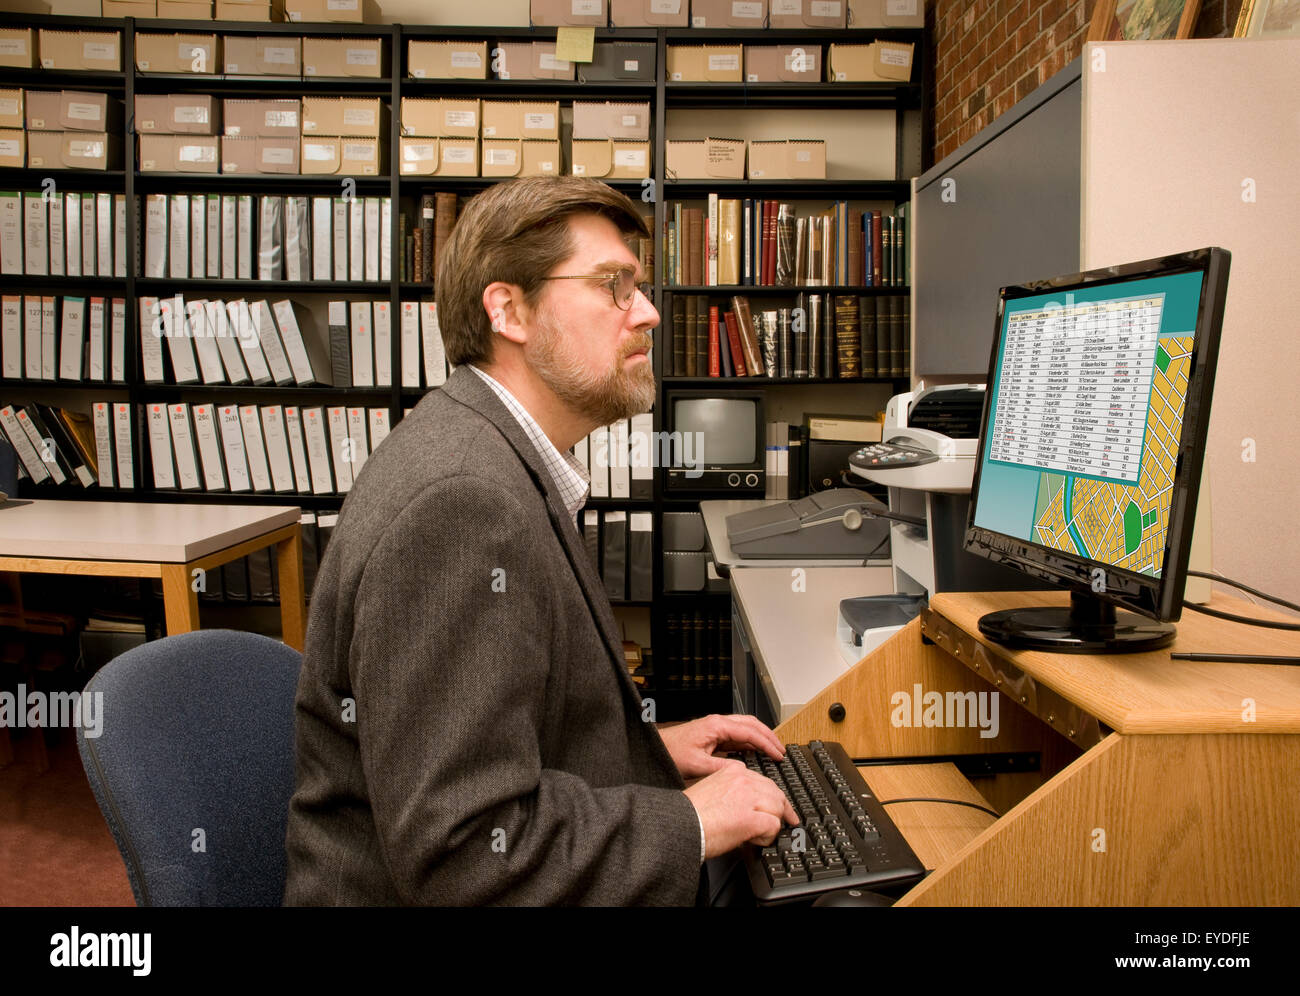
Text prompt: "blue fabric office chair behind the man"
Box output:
[[77, 629, 302, 906]]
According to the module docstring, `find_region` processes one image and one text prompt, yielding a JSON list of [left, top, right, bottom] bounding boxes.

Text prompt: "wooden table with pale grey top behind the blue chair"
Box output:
[[0, 499, 306, 651]]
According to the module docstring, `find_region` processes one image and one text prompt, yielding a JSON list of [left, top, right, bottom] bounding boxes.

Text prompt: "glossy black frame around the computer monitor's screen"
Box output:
[[963, 247, 1231, 622]]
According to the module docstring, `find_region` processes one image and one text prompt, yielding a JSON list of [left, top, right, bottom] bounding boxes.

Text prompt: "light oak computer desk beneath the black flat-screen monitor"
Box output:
[[776, 592, 1300, 906]]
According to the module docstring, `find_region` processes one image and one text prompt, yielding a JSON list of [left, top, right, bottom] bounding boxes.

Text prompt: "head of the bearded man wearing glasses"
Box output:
[[437, 177, 659, 425]]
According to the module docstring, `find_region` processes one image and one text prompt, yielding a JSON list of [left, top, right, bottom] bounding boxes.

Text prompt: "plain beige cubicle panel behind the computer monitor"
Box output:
[[1080, 38, 1300, 599]]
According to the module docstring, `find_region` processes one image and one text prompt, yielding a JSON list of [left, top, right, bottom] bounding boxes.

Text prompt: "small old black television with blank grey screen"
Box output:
[[664, 390, 767, 497]]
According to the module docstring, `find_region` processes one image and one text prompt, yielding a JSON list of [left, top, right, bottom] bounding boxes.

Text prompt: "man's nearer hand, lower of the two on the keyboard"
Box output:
[[686, 758, 800, 859]]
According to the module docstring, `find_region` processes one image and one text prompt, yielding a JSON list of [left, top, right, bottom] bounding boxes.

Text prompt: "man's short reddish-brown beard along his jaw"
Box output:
[[528, 306, 654, 425]]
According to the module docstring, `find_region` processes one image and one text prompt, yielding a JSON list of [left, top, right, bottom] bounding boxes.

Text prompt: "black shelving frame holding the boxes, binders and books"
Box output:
[[0, 13, 932, 719]]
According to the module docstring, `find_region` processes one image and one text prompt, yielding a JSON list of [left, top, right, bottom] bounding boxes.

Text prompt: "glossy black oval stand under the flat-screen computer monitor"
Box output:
[[979, 592, 1177, 654]]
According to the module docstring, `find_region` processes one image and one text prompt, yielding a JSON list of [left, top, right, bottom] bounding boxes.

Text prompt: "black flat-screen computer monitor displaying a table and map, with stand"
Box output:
[[965, 248, 1231, 653]]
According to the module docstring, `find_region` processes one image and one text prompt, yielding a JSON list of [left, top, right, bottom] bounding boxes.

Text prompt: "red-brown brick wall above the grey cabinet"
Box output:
[[926, 0, 1242, 163]]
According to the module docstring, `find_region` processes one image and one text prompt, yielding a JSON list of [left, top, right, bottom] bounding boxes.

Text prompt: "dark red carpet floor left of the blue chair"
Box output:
[[0, 729, 135, 906]]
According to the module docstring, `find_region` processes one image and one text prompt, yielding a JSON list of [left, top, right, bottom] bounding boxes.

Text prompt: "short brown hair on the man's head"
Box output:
[[436, 177, 650, 364]]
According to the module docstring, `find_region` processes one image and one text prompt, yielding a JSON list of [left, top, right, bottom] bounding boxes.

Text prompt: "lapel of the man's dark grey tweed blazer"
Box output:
[[442, 367, 641, 711]]
